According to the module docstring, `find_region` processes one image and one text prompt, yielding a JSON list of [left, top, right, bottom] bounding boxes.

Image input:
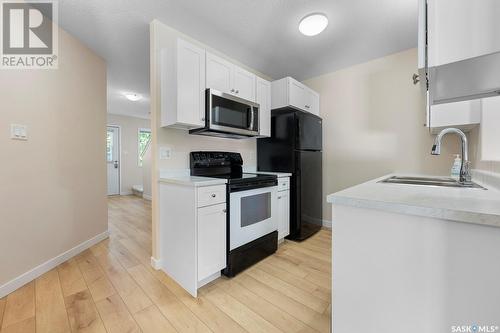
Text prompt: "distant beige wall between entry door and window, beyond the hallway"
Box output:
[[108, 114, 151, 195]]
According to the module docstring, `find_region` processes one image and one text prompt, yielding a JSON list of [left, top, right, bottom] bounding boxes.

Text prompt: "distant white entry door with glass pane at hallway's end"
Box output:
[[106, 126, 120, 195]]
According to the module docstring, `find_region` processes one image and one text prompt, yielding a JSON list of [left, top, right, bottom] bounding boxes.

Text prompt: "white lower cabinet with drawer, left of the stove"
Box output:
[[160, 181, 226, 297]]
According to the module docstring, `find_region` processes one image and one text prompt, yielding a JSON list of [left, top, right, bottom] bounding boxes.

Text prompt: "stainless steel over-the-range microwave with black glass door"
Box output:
[[189, 89, 259, 139]]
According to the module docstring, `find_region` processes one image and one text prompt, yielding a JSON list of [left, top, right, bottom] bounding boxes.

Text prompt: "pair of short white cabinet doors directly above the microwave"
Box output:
[[206, 52, 256, 102]]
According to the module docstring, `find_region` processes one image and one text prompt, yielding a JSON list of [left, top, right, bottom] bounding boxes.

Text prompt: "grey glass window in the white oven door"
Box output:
[[241, 192, 271, 228]]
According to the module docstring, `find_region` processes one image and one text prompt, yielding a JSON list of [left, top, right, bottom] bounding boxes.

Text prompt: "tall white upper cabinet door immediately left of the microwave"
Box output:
[[177, 39, 205, 127]]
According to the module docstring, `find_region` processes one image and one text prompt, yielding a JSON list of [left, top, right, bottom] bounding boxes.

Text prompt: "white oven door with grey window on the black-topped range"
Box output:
[[229, 186, 278, 251]]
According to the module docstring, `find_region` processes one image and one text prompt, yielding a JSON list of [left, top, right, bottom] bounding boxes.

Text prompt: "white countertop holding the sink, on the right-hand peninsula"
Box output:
[[327, 174, 500, 227]]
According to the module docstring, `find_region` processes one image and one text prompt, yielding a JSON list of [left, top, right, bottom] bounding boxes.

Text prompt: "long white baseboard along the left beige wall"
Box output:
[[0, 231, 109, 298]]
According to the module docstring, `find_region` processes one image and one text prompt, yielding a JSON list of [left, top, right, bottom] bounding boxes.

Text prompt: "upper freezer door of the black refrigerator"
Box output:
[[295, 111, 322, 150]]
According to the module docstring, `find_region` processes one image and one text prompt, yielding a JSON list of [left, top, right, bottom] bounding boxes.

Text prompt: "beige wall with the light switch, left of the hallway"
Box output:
[[0, 30, 108, 288]]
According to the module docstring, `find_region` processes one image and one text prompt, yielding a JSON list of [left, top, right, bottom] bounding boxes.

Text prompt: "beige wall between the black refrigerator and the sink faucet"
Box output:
[[304, 49, 459, 220]]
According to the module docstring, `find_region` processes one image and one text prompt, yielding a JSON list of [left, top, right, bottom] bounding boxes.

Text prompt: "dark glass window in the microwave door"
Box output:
[[211, 95, 251, 129]]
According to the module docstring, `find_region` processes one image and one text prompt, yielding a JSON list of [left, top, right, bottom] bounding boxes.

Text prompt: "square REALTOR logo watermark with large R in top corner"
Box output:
[[0, 0, 58, 69]]
